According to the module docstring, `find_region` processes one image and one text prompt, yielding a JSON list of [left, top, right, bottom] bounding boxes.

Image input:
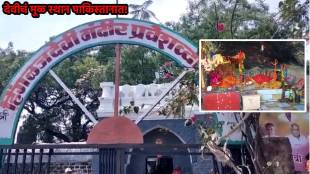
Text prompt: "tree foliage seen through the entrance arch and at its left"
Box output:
[[0, 42, 165, 143]]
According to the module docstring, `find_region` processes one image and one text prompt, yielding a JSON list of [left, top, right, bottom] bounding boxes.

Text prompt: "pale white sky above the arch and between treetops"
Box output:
[[0, 0, 279, 51]]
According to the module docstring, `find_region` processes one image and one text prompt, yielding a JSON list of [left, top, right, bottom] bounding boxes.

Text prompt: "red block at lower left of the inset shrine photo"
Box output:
[[202, 92, 241, 110]]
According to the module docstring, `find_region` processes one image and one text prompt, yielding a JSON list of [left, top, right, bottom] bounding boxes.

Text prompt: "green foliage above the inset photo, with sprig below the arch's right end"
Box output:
[[161, 0, 309, 119]]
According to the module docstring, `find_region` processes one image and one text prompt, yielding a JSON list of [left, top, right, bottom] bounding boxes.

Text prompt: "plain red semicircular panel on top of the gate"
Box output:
[[87, 116, 143, 144]]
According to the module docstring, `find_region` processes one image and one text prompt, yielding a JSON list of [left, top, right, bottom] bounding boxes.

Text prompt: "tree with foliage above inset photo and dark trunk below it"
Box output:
[[161, 0, 309, 174]]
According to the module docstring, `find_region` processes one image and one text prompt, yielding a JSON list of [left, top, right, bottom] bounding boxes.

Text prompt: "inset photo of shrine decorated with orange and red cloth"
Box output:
[[200, 41, 305, 111]]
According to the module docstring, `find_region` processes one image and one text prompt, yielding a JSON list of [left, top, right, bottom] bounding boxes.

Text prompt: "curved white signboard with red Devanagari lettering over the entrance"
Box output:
[[0, 18, 198, 144]]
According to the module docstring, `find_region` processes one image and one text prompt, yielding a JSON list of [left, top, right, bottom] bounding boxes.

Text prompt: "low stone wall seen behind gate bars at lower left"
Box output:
[[0, 149, 97, 174]]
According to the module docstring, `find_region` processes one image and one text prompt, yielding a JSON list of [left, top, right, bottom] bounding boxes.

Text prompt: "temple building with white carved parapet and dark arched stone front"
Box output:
[[97, 82, 240, 174]]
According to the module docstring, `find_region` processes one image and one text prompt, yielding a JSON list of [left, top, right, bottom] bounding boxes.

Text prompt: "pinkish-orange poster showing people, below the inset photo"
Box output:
[[260, 113, 309, 171]]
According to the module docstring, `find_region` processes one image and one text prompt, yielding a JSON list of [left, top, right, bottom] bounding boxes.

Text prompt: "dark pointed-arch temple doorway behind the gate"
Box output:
[[126, 127, 192, 174]]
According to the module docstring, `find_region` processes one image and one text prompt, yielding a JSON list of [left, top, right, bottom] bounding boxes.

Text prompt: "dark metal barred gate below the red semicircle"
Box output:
[[0, 144, 218, 174]]
